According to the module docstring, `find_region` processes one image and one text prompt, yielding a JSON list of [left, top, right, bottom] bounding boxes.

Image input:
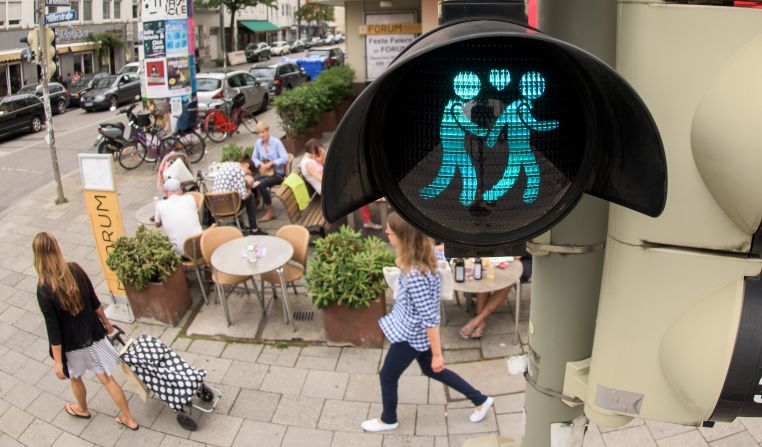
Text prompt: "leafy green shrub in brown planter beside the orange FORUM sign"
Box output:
[[106, 225, 191, 326]]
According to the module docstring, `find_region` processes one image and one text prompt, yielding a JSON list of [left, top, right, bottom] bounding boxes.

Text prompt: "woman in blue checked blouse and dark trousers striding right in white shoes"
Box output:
[[362, 213, 493, 432]]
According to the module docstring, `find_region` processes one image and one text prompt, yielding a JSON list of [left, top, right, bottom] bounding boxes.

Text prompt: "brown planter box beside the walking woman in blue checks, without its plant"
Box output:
[[323, 294, 386, 348]]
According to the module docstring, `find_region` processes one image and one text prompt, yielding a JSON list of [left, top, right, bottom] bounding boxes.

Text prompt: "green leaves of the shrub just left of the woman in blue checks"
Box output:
[[305, 226, 394, 309]]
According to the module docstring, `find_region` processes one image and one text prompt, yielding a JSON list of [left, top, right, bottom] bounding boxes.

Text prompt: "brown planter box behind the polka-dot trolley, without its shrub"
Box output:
[[125, 269, 191, 326]]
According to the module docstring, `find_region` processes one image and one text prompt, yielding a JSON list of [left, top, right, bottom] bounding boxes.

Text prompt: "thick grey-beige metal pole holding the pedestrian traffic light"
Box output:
[[522, 0, 617, 447]]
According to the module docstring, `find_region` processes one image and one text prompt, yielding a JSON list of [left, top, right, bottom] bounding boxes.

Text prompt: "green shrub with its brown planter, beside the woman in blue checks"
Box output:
[[306, 226, 394, 347]]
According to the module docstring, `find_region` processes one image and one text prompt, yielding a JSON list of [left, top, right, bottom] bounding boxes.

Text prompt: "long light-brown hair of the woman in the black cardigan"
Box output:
[[32, 232, 83, 315]]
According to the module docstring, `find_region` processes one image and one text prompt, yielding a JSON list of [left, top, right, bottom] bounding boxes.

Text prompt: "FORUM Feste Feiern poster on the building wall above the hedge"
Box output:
[[365, 12, 415, 81]]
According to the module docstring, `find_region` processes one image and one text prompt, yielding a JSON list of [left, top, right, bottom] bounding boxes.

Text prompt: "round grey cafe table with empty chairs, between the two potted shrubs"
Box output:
[[212, 236, 296, 331]]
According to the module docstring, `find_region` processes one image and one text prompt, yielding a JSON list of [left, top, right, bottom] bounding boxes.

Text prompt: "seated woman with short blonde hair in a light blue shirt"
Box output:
[[251, 121, 288, 222]]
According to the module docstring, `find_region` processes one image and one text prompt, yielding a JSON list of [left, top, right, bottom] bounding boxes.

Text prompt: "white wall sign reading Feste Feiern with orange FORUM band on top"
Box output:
[[361, 12, 420, 80]]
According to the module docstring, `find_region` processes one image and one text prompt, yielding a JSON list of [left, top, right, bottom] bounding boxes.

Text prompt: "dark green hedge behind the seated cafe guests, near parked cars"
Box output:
[[274, 65, 355, 138]]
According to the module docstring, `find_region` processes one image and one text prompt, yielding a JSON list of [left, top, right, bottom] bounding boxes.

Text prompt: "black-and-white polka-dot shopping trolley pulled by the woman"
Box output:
[[109, 326, 222, 431]]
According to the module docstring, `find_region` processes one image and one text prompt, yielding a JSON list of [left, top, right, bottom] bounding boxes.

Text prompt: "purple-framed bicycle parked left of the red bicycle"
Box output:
[[119, 113, 188, 169]]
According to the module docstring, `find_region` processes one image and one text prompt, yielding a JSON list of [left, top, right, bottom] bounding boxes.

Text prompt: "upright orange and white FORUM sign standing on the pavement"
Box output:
[[79, 154, 126, 296]]
